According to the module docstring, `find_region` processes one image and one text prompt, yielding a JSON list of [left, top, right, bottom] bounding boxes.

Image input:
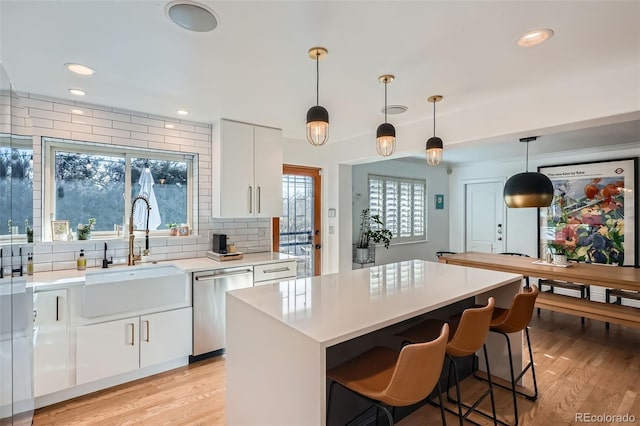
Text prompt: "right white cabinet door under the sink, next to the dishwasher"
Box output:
[[140, 308, 192, 368]]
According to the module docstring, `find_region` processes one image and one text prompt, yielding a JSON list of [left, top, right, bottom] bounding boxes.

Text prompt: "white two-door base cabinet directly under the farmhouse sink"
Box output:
[[76, 307, 192, 384]]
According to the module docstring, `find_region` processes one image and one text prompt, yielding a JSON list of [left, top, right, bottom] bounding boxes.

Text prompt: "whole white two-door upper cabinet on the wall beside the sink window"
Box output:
[[211, 120, 282, 218]]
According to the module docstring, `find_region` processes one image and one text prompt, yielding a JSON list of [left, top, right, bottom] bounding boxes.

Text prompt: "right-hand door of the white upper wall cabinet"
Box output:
[[254, 126, 282, 217]]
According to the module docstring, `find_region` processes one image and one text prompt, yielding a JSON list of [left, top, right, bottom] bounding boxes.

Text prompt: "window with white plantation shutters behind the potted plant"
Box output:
[[369, 175, 427, 243]]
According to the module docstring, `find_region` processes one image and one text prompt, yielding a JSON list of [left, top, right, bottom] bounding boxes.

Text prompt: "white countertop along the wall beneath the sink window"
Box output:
[[27, 252, 296, 291]]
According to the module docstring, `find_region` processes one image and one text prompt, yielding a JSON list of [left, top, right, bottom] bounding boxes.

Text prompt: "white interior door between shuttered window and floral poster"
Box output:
[[465, 181, 506, 253]]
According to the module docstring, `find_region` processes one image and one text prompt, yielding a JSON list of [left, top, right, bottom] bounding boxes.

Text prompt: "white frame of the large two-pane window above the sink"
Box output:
[[42, 136, 199, 241]]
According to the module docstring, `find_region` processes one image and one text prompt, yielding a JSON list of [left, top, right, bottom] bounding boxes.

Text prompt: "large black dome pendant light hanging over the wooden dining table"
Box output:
[[503, 136, 553, 208]]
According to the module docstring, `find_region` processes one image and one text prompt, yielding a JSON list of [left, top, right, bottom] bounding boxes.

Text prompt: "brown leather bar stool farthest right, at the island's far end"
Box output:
[[474, 285, 538, 425]]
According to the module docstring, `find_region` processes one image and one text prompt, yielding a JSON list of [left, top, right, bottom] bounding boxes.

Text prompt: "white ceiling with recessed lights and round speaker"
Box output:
[[0, 0, 640, 162]]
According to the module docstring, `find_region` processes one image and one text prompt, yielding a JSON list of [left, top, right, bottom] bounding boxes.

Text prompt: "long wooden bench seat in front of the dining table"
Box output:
[[536, 292, 640, 328]]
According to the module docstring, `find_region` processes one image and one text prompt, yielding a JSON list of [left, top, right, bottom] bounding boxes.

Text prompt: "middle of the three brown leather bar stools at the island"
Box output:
[[398, 297, 498, 425]]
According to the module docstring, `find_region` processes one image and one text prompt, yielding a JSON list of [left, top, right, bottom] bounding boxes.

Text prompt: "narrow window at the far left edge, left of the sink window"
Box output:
[[0, 135, 33, 238]]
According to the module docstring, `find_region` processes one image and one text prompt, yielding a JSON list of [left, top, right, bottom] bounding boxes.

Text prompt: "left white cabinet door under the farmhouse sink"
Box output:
[[76, 317, 139, 384]]
